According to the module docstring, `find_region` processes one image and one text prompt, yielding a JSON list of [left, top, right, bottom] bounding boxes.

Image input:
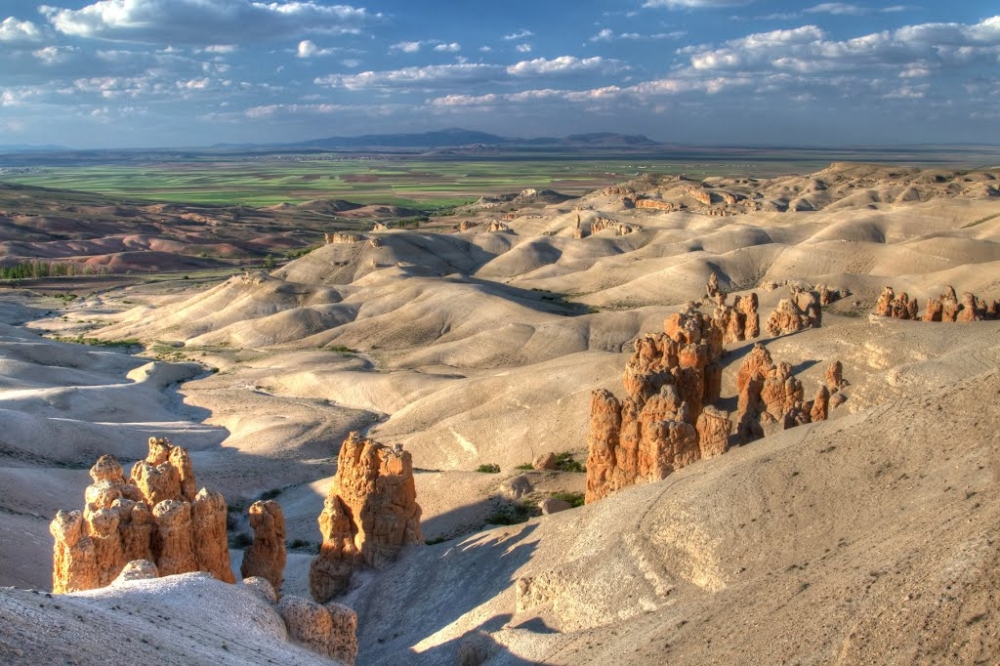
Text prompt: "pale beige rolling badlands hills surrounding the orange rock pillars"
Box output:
[[0, 164, 1000, 664]]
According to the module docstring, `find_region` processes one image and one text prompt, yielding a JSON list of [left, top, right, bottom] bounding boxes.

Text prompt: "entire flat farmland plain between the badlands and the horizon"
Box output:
[[0, 146, 997, 211]]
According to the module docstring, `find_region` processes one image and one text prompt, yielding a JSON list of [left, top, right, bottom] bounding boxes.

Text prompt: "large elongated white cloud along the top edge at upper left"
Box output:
[[39, 0, 381, 44]]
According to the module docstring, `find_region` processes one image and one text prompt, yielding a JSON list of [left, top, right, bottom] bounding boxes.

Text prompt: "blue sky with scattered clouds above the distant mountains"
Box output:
[[0, 0, 1000, 148]]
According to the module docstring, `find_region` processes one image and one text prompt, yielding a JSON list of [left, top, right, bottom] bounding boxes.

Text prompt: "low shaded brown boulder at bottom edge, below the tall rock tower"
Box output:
[[278, 596, 358, 664]]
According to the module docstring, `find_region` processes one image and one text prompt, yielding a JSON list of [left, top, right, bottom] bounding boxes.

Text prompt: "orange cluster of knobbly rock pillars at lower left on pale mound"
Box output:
[[49, 438, 234, 593]]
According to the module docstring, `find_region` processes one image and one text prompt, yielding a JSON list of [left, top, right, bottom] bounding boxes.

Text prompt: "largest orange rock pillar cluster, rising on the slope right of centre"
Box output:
[[586, 304, 731, 503]]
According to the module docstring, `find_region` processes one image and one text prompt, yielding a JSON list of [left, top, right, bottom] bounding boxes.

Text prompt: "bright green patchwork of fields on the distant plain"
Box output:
[[0, 158, 824, 210]]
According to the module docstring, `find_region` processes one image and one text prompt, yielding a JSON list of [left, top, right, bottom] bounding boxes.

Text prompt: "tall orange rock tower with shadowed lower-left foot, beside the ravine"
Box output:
[[309, 433, 423, 603]]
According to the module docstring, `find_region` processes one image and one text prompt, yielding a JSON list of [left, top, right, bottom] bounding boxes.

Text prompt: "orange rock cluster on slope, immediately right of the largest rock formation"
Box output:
[[736, 343, 847, 444]]
